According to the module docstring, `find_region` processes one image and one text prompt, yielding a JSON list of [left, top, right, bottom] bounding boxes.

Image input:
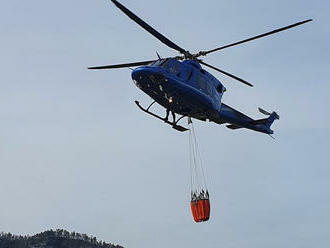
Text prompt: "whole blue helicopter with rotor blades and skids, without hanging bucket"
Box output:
[[88, 0, 312, 135]]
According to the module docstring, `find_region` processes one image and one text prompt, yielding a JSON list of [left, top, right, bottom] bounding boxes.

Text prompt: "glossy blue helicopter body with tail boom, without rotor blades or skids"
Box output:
[[132, 58, 277, 134]]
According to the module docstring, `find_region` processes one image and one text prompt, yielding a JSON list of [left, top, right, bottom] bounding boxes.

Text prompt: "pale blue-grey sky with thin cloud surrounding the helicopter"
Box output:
[[0, 0, 330, 248]]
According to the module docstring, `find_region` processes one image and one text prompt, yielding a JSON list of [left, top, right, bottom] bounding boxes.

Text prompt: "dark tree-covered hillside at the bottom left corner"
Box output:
[[0, 229, 123, 248]]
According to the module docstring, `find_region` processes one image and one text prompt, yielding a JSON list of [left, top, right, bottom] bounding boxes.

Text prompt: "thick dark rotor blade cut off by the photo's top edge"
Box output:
[[111, 0, 187, 54]]
